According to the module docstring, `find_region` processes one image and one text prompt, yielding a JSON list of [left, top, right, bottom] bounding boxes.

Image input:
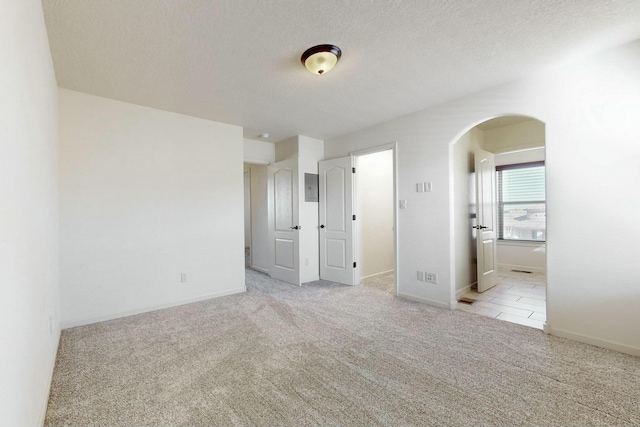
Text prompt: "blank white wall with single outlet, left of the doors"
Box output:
[[59, 89, 244, 326]]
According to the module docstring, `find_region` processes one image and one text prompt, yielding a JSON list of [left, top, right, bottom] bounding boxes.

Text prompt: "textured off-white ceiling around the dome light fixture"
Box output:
[[43, 0, 640, 141]]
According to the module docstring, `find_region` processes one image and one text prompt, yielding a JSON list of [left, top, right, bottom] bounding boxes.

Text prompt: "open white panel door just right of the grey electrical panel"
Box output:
[[318, 157, 356, 285]]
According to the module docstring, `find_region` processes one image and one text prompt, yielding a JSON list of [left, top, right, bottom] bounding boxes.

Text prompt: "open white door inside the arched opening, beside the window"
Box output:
[[473, 148, 498, 292]]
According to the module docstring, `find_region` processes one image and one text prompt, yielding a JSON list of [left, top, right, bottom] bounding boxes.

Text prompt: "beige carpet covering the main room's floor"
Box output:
[[45, 270, 640, 426]]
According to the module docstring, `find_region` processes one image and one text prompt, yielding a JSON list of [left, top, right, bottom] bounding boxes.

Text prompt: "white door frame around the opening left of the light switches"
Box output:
[[349, 141, 400, 296]]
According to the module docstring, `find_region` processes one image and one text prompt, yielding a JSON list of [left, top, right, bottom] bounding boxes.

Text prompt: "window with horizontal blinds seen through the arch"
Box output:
[[496, 162, 547, 242]]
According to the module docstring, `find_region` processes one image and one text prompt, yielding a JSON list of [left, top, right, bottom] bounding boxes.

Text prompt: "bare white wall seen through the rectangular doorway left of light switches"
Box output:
[[356, 150, 394, 280]]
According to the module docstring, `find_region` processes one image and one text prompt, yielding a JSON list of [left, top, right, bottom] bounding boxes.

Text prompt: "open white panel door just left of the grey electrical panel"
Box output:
[[269, 159, 301, 286]]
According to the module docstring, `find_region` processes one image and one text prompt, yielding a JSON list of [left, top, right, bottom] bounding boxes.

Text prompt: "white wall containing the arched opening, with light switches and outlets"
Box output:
[[325, 42, 640, 355]]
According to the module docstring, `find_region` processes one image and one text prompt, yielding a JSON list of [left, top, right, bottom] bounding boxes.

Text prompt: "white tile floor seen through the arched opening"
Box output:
[[458, 270, 547, 329]]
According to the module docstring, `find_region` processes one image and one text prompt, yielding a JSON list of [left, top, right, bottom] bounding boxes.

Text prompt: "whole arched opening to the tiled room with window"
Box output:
[[452, 116, 547, 329]]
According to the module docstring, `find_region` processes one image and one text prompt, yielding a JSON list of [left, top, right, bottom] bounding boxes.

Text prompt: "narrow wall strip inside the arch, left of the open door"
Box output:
[[451, 128, 484, 299]]
